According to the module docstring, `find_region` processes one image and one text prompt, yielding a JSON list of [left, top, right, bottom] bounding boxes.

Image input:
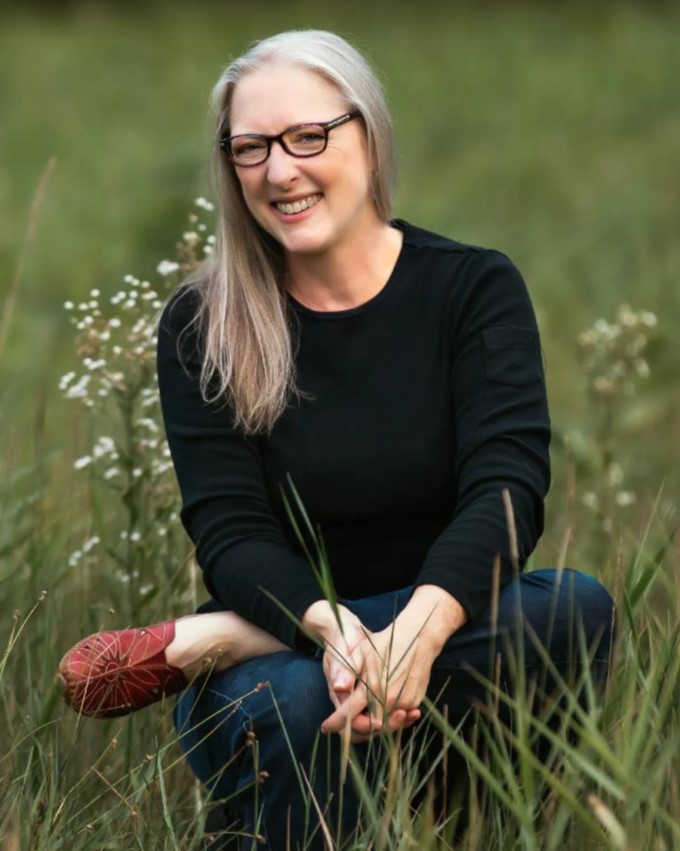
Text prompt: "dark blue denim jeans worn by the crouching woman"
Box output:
[[175, 570, 614, 851]]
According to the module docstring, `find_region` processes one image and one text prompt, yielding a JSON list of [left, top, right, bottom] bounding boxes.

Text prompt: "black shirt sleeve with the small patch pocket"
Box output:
[[416, 251, 550, 620]]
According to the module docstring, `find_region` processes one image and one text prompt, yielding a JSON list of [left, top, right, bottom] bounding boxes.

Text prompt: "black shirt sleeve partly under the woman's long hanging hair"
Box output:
[[157, 290, 323, 646]]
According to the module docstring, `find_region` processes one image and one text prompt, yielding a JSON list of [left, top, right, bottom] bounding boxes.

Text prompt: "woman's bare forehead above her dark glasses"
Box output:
[[229, 62, 346, 135]]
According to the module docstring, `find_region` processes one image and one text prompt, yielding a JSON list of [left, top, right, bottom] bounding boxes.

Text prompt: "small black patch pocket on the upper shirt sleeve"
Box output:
[[482, 326, 543, 387]]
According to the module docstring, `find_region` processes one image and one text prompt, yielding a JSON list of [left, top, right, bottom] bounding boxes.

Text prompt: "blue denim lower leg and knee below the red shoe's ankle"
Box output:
[[175, 651, 357, 851]]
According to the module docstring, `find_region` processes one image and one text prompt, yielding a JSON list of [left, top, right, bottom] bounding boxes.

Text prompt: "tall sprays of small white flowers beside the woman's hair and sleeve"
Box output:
[[59, 198, 214, 597]]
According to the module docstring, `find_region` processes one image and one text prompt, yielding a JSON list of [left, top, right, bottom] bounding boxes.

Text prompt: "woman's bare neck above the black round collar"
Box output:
[[286, 220, 402, 311]]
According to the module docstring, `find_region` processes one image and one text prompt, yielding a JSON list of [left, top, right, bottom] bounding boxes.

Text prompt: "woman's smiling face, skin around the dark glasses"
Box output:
[[230, 63, 379, 258]]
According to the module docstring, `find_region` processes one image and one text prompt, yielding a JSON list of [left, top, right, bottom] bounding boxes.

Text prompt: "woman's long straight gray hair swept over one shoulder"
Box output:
[[187, 30, 395, 434]]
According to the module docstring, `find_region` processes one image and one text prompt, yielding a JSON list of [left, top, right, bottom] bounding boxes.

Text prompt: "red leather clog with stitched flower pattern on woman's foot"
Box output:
[[58, 620, 188, 718]]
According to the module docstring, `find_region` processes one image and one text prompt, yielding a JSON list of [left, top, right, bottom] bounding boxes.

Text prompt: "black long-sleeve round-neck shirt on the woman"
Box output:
[[158, 221, 550, 645]]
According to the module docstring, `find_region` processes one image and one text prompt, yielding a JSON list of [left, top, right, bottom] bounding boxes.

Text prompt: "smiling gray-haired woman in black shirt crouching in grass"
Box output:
[[60, 31, 612, 849]]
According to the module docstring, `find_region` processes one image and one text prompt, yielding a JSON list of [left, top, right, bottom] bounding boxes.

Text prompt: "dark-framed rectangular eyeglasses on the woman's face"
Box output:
[[219, 109, 361, 168]]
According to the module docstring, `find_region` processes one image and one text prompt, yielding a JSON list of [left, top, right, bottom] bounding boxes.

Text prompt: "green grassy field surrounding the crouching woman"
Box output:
[[0, 0, 680, 851]]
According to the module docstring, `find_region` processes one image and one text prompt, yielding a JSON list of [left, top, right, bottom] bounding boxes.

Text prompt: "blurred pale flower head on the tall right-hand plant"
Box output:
[[578, 304, 657, 398]]
